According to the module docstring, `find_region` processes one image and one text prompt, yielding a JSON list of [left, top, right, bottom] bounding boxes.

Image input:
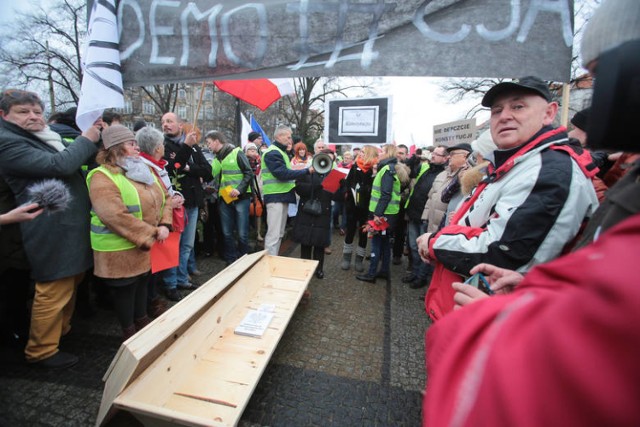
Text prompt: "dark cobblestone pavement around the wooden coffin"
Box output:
[[0, 233, 428, 427]]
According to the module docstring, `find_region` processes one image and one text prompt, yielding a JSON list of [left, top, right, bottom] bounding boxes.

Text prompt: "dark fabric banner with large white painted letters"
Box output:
[[117, 0, 573, 86]]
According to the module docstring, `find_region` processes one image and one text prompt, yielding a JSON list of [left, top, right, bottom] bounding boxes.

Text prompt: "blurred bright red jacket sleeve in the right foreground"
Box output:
[[423, 215, 640, 426]]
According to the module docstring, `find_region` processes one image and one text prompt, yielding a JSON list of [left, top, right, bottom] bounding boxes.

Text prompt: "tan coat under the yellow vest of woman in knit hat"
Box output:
[[89, 166, 173, 279]]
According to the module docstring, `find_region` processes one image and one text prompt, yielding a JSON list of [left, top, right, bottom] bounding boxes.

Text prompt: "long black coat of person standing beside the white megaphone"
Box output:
[[292, 173, 331, 248]]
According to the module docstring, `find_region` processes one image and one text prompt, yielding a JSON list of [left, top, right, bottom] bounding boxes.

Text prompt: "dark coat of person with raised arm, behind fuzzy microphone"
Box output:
[[0, 119, 98, 282]]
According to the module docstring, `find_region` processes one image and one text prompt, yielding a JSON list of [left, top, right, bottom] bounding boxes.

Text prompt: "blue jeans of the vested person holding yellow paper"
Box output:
[[218, 199, 251, 264]]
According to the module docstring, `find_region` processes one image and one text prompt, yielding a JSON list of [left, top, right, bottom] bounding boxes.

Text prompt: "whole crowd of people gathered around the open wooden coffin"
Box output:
[[0, 0, 640, 425]]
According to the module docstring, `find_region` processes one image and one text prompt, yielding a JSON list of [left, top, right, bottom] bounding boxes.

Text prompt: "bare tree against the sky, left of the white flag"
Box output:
[[0, 0, 87, 111]]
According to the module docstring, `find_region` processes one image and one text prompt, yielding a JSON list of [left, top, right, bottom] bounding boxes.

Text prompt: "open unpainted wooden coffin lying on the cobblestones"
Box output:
[[96, 251, 318, 426]]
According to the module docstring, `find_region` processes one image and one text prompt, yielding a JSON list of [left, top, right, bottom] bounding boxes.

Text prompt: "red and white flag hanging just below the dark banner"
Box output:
[[213, 79, 295, 111]]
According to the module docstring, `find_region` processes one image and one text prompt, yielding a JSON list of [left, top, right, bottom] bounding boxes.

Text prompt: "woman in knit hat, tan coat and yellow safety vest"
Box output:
[[87, 125, 172, 340]]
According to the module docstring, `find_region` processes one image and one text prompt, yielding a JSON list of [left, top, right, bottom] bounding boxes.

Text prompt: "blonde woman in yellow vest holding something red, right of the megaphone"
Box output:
[[356, 144, 409, 283]]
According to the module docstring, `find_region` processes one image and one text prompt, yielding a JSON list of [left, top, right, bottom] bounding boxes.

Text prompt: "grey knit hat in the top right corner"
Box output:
[[581, 0, 640, 67]]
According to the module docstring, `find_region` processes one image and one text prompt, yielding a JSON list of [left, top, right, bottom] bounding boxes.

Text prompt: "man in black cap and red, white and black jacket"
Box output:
[[418, 76, 598, 320]]
